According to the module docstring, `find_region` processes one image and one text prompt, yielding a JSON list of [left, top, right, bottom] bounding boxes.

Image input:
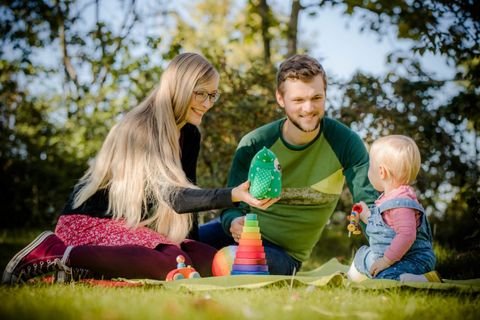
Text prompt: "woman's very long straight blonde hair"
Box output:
[[74, 53, 219, 243]]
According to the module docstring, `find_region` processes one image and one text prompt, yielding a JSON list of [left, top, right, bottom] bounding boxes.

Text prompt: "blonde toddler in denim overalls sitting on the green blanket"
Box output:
[[348, 135, 441, 282]]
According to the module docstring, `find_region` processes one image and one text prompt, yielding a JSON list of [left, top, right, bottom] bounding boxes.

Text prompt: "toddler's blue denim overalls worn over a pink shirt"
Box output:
[[354, 198, 435, 280]]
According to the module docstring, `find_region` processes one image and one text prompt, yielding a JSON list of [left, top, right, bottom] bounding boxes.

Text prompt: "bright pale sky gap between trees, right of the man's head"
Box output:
[[299, 8, 455, 79]]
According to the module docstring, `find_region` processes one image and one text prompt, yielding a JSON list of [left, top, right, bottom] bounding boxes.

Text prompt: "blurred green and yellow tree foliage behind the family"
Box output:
[[0, 0, 480, 252]]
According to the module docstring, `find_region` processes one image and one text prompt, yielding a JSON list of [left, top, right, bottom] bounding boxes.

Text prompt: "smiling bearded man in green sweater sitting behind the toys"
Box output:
[[200, 55, 377, 275]]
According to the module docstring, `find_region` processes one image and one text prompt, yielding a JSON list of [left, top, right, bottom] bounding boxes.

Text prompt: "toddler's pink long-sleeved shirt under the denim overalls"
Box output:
[[375, 185, 421, 262]]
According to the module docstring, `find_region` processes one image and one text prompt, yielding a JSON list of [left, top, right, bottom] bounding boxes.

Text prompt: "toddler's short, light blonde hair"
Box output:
[[370, 135, 421, 184]]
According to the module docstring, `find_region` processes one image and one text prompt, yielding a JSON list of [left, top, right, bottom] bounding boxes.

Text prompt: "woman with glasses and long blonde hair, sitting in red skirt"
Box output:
[[2, 53, 275, 283]]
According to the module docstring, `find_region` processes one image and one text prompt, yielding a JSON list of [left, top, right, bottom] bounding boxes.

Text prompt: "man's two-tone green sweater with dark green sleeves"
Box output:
[[221, 118, 377, 261]]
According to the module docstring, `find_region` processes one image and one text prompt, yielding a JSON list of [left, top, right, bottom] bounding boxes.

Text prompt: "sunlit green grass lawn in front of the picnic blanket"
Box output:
[[0, 232, 480, 320]]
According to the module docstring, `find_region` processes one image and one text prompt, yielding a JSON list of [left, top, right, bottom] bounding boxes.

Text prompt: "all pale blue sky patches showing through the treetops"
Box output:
[[31, 0, 455, 97]]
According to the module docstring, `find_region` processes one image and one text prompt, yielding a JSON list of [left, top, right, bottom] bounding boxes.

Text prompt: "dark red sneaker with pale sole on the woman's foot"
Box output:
[[2, 231, 70, 284]]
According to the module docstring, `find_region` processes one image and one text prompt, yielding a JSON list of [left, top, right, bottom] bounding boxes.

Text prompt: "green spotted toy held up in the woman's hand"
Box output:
[[248, 147, 282, 199]]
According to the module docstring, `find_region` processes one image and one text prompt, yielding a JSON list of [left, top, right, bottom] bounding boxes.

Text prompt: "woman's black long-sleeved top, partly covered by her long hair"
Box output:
[[61, 123, 233, 239]]
